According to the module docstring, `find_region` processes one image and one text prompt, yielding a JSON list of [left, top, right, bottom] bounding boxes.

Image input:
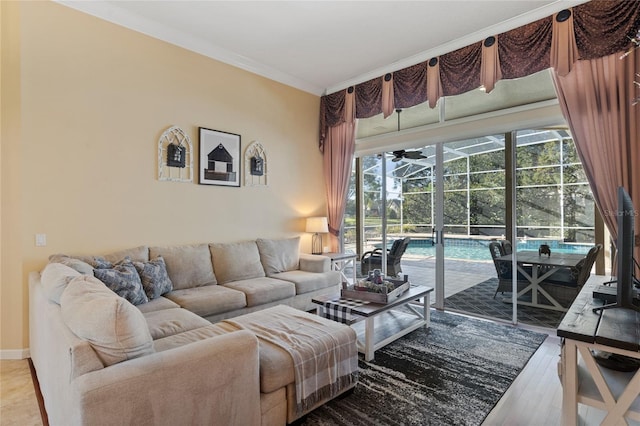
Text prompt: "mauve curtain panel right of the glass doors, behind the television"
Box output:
[[552, 50, 640, 259]]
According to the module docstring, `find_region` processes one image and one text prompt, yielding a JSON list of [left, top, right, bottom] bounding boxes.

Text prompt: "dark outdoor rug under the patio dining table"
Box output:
[[444, 278, 565, 328]]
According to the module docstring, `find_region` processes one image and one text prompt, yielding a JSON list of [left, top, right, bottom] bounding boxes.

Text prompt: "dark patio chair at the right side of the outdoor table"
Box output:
[[540, 244, 602, 306]]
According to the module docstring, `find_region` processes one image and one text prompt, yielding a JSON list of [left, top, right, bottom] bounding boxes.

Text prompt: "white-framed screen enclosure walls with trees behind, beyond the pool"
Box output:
[[344, 129, 595, 250]]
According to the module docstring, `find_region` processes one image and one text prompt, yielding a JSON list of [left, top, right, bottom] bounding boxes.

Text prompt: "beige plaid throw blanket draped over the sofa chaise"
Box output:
[[224, 306, 358, 414]]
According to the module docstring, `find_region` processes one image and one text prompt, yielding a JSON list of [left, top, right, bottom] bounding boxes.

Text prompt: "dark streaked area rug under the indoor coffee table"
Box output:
[[300, 311, 547, 426]]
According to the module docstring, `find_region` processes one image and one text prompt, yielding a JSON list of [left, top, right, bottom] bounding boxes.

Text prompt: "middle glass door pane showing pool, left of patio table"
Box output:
[[442, 135, 504, 321]]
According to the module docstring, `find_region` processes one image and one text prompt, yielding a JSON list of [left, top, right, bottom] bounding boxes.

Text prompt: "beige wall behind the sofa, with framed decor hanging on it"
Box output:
[[0, 2, 326, 354]]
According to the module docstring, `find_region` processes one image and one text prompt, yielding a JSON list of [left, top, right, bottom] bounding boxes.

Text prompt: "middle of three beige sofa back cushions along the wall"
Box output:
[[209, 241, 264, 284]]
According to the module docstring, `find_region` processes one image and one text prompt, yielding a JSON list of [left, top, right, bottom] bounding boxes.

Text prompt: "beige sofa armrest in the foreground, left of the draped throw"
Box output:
[[69, 330, 260, 425]]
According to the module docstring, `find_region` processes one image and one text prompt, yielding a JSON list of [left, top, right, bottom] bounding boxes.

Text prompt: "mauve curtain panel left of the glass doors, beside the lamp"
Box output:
[[323, 91, 356, 252]]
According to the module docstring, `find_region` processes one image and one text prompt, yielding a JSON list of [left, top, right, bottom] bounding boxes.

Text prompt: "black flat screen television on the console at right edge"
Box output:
[[594, 186, 640, 311]]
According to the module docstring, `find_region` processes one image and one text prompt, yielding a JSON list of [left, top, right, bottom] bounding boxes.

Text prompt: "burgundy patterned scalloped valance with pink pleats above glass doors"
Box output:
[[320, 0, 640, 150]]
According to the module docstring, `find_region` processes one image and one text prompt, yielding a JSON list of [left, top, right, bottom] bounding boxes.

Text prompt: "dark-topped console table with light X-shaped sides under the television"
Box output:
[[557, 283, 640, 425]]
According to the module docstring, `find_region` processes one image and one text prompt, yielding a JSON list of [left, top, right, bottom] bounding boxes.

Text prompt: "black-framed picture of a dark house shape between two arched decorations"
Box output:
[[198, 127, 242, 187]]
